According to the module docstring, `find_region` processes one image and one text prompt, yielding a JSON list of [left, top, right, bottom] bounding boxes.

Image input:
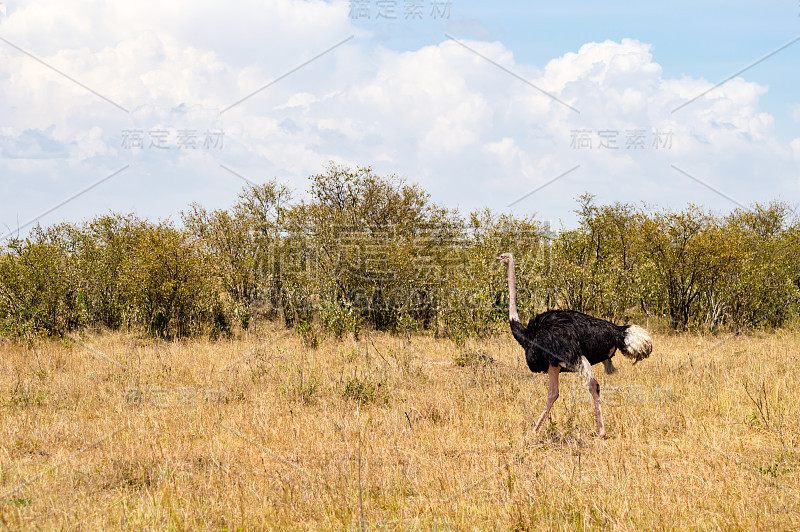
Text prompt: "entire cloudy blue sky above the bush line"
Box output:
[[0, 0, 800, 240]]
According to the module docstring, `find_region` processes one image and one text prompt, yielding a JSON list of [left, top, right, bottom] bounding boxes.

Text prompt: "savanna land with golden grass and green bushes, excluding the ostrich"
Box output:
[[0, 163, 800, 530]]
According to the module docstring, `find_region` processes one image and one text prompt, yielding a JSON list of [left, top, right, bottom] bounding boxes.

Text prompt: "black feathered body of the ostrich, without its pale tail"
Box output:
[[511, 310, 628, 373]]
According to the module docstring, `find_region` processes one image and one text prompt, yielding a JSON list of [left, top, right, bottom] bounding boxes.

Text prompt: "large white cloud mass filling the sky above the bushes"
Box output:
[[0, 0, 800, 232]]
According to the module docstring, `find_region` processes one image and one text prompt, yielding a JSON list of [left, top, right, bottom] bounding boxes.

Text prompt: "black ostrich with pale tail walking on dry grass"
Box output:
[[498, 253, 653, 438]]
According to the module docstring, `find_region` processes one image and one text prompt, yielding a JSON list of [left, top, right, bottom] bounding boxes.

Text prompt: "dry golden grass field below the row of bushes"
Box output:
[[0, 323, 800, 530]]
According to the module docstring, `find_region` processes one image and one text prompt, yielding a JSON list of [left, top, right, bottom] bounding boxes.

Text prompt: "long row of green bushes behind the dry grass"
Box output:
[[0, 164, 800, 338]]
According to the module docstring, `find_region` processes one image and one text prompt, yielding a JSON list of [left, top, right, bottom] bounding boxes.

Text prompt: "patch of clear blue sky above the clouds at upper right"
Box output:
[[355, 0, 800, 140]]
